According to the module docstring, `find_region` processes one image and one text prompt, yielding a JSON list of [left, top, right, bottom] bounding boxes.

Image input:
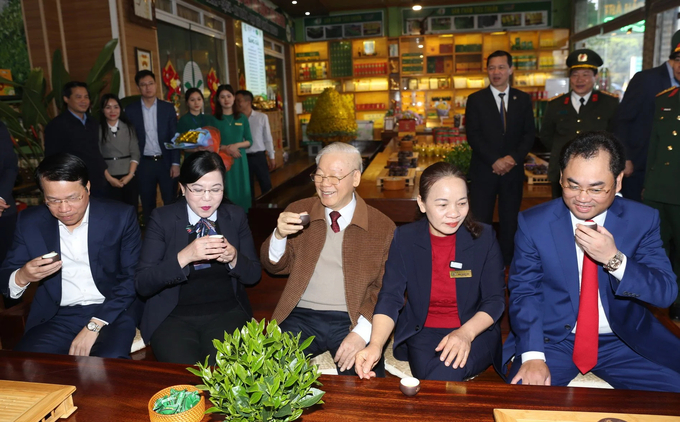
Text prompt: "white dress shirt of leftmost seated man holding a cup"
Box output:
[[9, 205, 107, 324]]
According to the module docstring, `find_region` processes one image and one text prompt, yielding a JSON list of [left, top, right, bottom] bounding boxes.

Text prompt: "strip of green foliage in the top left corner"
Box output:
[[0, 0, 30, 86]]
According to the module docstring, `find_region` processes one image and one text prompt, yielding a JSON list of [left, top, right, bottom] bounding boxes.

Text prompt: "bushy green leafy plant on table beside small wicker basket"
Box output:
[[187, 320, 324, 421]]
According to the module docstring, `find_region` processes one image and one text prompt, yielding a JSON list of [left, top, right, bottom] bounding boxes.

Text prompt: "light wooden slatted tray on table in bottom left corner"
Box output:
[[0, 381, 77, 422]]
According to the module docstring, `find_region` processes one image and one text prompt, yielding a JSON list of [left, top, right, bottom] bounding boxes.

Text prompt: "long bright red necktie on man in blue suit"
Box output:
[[573, 220, 599, 374]]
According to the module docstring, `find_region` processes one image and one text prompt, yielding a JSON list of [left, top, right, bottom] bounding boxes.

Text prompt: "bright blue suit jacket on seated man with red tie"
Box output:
[[503, 197, 680, 372]]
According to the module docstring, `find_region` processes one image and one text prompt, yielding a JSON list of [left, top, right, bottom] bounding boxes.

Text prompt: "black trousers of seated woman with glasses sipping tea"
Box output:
[[151, 306, 250, 365]]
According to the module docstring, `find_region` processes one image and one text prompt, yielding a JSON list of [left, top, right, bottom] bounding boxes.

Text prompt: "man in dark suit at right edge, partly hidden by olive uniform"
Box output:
[[614, 31, 680, 201]]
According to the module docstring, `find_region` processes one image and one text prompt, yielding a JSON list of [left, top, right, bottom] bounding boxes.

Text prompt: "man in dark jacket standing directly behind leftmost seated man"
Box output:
[[45, 81, 108, 197]]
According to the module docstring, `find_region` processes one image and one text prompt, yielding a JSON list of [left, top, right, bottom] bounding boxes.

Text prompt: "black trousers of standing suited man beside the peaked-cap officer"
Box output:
[[470, 164, 524, 266]]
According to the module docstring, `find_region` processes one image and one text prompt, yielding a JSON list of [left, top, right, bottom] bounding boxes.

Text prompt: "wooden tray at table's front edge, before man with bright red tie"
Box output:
[[493, 409, 680, 422]]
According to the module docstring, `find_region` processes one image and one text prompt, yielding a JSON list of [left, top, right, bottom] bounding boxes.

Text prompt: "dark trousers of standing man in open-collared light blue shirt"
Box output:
[[137, 156, 177, 224]]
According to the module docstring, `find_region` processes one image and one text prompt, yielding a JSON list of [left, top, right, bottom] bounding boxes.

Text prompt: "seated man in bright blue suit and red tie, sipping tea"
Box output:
[[503, 132, 680, 392]]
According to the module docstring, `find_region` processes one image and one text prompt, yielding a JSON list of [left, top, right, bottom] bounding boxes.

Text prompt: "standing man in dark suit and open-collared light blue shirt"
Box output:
[[125, 70, 180, 224]]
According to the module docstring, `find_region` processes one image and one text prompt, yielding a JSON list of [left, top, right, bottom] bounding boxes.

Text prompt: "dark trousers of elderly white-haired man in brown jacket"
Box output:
[[279, 308, 385, 378]]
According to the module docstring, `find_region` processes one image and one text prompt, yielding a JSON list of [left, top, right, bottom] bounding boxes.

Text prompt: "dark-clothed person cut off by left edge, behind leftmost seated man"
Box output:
[[0, 122, 19, 308]]
